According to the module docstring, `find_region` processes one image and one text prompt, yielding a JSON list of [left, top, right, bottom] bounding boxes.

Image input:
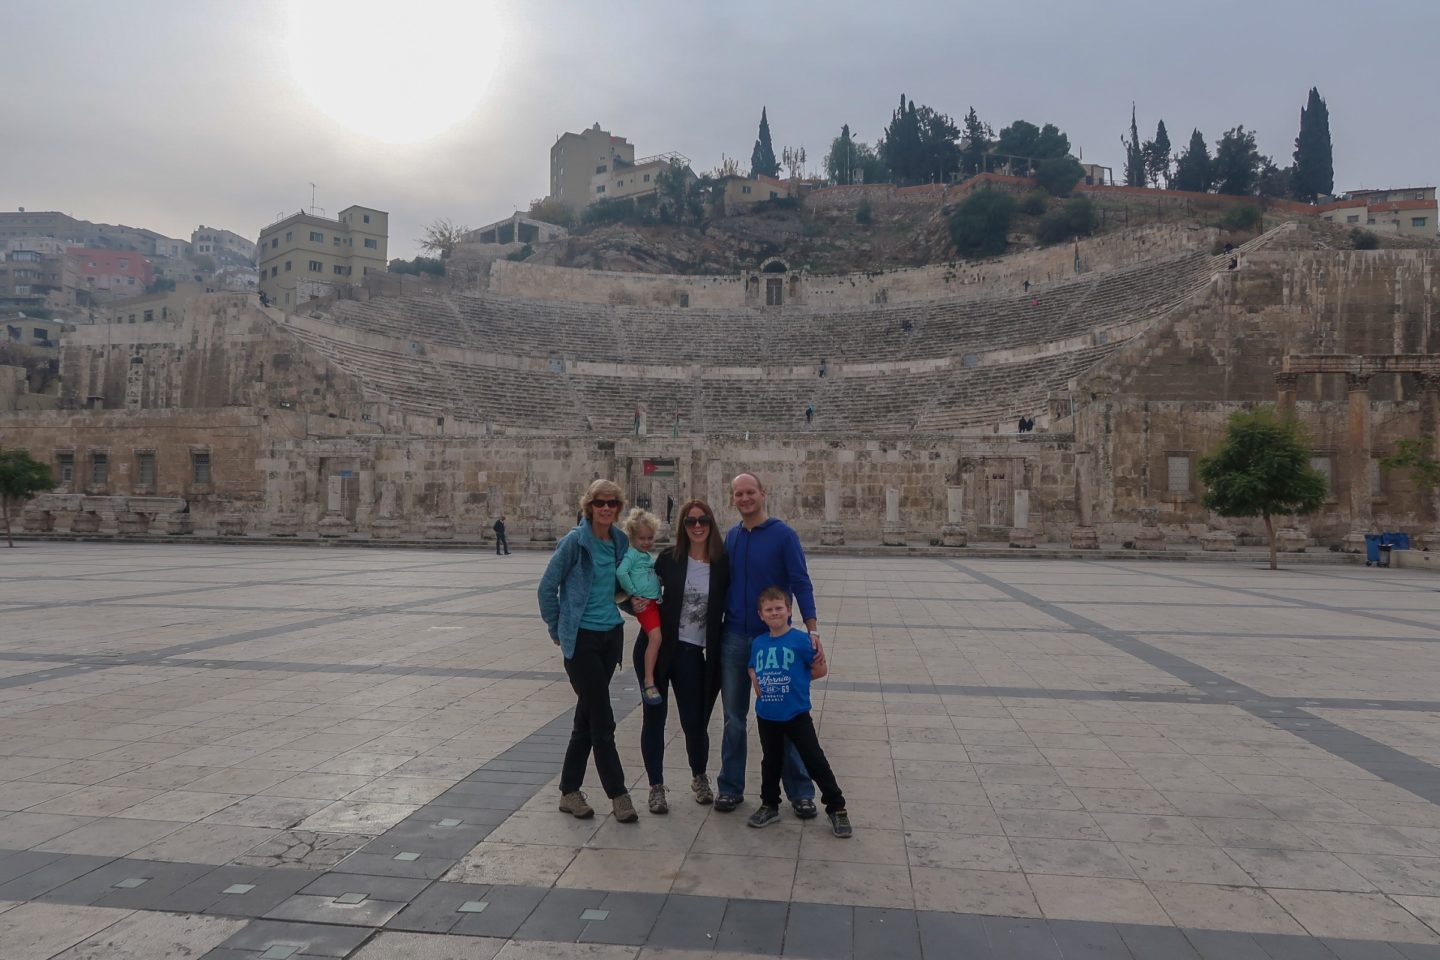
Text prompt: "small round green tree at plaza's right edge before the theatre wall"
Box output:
[[1200, 407, 1326, 570]]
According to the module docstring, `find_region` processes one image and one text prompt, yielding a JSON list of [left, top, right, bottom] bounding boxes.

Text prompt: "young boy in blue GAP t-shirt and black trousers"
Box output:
[[747, 587, 854, 838]]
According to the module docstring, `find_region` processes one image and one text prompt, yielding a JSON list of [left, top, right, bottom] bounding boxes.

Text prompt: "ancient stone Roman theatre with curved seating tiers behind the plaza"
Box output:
[[0, 220, 1437, 550]]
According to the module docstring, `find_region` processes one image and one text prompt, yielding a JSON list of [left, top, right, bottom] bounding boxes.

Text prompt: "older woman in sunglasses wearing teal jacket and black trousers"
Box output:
[[539, 479, 639, 823]]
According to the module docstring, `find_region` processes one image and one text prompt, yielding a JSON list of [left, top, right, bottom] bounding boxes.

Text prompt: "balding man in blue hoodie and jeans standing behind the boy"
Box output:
[[716, 474, 825, 819]]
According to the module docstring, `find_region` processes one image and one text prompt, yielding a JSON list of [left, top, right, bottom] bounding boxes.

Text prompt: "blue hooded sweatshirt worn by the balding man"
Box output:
[[724, 517, 815, 640]]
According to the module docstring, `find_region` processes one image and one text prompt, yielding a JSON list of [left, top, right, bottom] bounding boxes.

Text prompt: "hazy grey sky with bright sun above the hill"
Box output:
[[0, 0, 1440, 256]]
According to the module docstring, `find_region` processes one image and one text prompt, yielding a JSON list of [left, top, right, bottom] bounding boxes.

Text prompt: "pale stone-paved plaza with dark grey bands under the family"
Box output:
[[0, 543, 1440, 960]]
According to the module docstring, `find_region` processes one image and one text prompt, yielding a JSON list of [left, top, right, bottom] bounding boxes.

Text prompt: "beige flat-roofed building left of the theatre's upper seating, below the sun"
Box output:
[[255, 206, 390, 308]]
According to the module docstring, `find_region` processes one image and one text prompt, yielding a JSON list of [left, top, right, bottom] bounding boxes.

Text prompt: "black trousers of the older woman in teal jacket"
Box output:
[[560, 625, 629, 797]]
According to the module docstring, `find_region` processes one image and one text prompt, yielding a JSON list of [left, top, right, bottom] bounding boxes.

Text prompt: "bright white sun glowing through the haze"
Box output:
[[287, 0, 505, 144]]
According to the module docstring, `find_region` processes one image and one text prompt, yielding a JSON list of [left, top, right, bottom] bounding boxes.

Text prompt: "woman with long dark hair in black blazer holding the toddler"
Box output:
[[632, 499, 730, 813]]
